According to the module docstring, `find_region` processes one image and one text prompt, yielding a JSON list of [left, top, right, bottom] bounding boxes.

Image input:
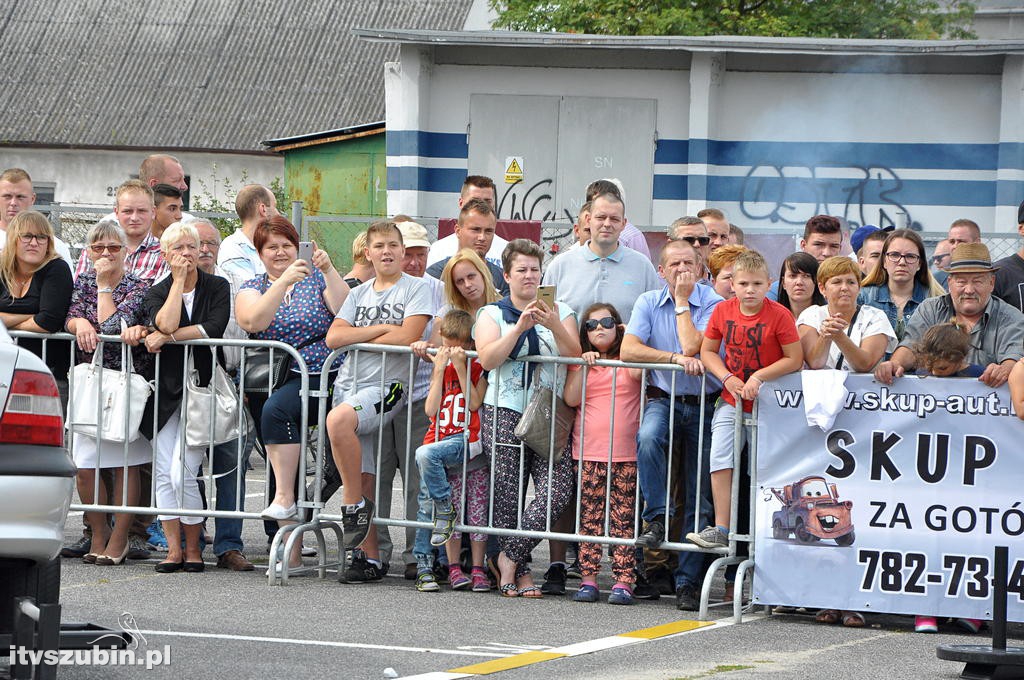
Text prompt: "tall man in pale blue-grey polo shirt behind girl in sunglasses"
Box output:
[[544, 188, 662, 323]]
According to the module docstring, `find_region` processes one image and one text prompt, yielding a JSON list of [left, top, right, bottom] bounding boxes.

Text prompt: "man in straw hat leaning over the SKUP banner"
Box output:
[[874, 243, 1024, 387]]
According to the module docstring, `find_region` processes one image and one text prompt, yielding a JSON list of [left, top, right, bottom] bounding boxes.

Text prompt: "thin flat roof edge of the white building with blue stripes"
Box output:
[[355, 27, 1024, 55]]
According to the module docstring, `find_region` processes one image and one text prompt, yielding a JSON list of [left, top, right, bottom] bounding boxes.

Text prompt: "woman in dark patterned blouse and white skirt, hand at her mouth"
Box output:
[[65, 220, 153, 565]]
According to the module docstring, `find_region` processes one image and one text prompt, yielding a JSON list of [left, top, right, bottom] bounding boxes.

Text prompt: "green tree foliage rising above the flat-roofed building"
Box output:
[[490, 0, 975, 40]]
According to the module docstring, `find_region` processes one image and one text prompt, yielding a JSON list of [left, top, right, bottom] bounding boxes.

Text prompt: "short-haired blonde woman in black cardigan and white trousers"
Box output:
[[141, 222, 231, 572]]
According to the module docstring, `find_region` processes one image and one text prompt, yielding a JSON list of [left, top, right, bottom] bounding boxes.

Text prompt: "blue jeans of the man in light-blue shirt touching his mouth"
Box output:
[[637, 398, 715, 587]]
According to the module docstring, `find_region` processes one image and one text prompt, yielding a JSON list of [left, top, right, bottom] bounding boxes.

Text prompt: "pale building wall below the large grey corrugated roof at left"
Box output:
[[0, 146, 285, 207]]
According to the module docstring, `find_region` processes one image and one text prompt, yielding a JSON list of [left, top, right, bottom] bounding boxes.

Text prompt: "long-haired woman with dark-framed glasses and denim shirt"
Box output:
[[857, 229, 945, 340]]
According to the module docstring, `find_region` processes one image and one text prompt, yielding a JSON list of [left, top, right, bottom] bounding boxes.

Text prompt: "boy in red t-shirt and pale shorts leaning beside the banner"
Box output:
[[686, 251, 804, 548]]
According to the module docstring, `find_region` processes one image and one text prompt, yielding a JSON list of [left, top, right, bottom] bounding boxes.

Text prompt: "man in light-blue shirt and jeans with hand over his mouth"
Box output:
[[622, 241, 722, 610]]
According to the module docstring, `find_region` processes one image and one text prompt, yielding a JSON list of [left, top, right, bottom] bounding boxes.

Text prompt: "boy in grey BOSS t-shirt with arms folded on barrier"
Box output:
[[327, 221, 433, 583]]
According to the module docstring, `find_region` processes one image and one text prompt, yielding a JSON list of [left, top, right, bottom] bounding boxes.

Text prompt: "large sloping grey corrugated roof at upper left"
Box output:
[[0, 0, 472, 151]]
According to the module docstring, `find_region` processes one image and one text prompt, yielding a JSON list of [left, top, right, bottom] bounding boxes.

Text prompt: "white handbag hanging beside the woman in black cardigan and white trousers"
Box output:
[[183, 353, 240, 449]]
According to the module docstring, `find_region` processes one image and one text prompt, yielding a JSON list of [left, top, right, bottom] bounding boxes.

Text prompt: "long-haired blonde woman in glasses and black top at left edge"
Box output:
[[0, 210, 73, 378]]
